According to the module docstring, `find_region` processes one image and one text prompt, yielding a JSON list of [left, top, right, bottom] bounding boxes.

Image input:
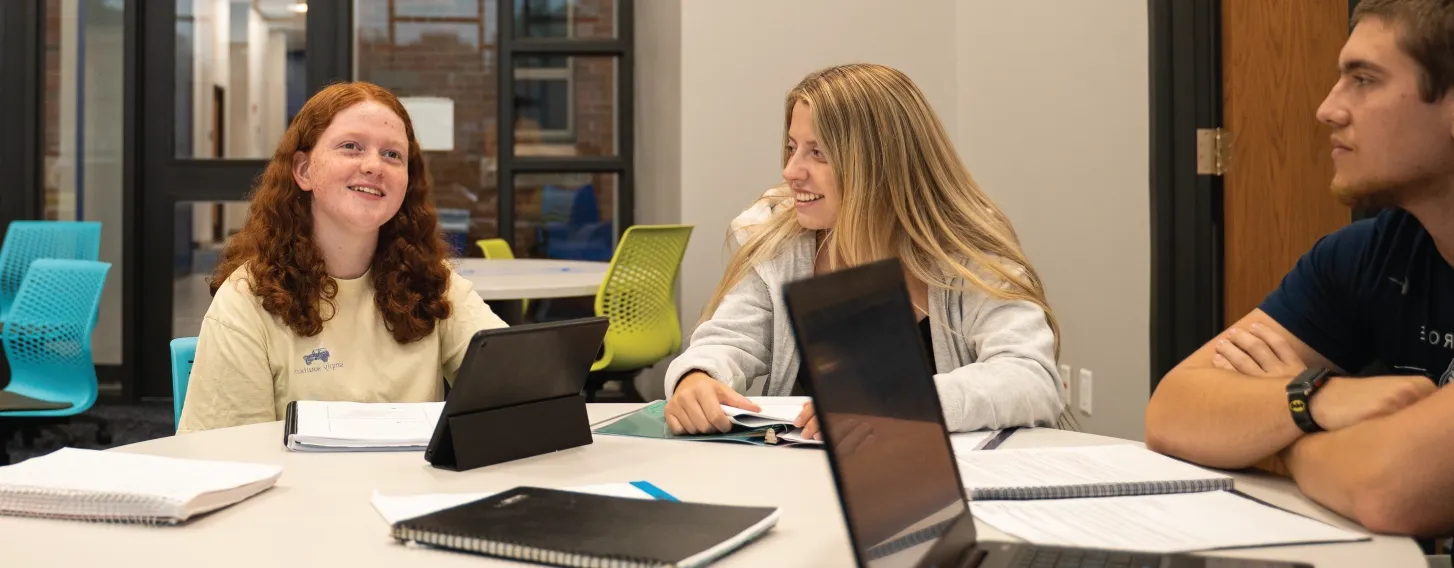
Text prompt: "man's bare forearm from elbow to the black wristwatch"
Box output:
[[1146, 369, 1303, 469]]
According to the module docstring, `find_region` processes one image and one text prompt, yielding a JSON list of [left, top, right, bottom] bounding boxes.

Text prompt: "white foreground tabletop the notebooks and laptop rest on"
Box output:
[[0, 404, 1426, 568]]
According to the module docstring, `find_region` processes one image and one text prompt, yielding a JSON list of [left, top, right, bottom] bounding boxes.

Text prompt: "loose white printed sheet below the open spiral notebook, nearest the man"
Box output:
[[970, 491, 1368, 552]]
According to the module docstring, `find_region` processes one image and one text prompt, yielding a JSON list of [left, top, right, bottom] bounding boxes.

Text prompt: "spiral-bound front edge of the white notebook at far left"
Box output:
[[0, 487, 179, 526]]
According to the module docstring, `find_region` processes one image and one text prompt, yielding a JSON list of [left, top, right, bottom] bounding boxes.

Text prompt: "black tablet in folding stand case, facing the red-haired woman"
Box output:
[[425, 317, 609, 465]]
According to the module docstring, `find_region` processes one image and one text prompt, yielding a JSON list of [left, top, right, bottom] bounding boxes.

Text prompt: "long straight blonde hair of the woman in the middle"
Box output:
[[704, 64, 1060, 359]]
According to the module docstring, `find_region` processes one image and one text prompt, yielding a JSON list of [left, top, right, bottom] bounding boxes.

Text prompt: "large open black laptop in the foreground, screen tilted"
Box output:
[[785, 259, 1312, 568]]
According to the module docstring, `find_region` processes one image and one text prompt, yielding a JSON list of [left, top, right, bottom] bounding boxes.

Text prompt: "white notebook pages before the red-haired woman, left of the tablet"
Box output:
[[286, 401, 445, 452]]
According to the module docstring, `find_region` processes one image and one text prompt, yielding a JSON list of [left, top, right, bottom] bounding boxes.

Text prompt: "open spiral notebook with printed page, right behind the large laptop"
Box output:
[[955, 445, 1233, 500]]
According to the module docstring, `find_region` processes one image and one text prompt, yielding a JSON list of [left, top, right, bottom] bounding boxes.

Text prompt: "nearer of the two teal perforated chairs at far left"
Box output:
[[0, 259, 111, 464]]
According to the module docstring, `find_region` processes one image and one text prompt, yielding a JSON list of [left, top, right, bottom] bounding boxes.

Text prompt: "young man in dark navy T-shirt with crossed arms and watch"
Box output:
[[1146, 0, 1454, 535]]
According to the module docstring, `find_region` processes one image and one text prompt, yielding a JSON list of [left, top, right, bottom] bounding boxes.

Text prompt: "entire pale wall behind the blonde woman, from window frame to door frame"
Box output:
[[635, 0, 1150, 439]]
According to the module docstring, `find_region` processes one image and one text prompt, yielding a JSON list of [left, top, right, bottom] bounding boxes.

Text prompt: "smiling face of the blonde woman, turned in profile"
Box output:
[[782, 102, 843, 231]]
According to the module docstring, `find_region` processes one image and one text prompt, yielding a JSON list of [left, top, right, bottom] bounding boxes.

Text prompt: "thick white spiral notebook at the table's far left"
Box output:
[[0, 447, 282, 524]]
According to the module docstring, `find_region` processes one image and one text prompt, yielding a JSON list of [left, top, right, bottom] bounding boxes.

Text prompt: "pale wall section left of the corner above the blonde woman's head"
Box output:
[[680, 0, 957, 348]]
